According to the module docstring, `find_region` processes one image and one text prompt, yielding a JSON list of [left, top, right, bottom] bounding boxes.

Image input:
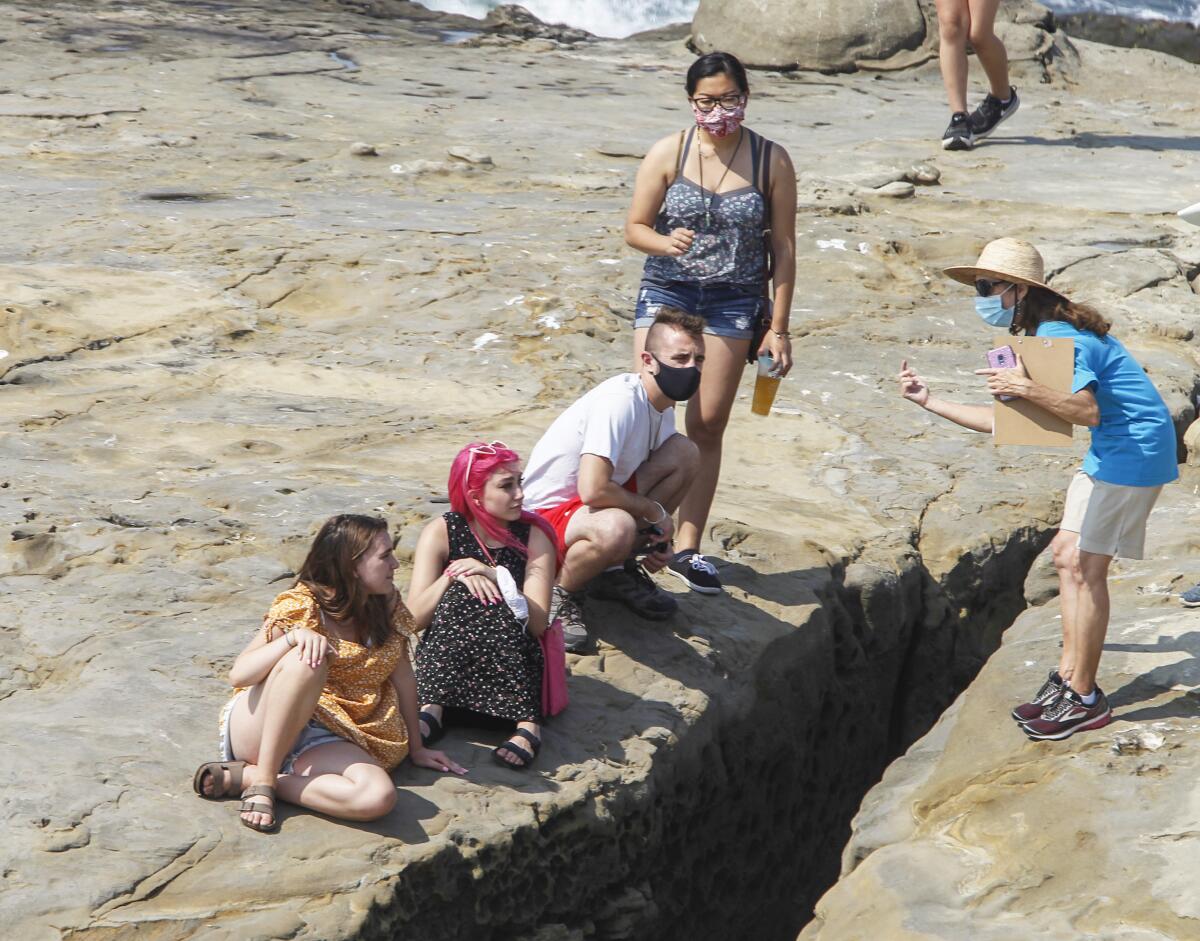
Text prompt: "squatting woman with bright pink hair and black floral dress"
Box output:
[[408, 442, 557, 768]]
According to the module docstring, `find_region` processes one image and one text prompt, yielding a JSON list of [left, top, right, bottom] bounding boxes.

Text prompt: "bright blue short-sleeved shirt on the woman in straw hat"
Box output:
[[1037, 320, 1180, 487]]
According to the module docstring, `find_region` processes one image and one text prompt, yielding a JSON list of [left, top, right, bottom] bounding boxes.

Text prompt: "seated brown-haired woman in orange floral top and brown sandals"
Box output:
[[193, 514, 466, 833]]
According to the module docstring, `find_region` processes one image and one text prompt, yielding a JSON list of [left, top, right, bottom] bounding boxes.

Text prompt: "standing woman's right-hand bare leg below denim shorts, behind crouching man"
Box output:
[[674, 335, 750, 551]]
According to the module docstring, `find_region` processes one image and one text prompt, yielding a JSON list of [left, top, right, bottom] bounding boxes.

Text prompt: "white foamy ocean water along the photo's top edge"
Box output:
[[420, 0, 1200, 36]]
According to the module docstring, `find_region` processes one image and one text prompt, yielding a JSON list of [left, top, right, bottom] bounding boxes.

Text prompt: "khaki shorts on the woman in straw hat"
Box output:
[[1058, 471, 1163, 558]]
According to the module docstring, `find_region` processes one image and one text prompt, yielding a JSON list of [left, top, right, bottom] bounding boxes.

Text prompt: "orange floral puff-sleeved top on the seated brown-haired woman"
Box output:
[[234, 585, 416, 771]]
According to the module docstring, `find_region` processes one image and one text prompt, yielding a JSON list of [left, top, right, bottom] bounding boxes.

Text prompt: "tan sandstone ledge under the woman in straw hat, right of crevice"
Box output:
[[800, 477, 1200, 941]]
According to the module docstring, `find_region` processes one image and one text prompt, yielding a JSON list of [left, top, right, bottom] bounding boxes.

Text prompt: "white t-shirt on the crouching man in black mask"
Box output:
[[524, 372, 674, 510]]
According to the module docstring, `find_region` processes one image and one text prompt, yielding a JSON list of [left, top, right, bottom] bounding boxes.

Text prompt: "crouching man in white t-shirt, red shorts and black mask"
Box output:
[[524, 307, 704, 651]]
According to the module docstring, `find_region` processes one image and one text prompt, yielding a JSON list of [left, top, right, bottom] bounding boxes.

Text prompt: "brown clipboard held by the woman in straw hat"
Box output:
[[992, 335, 1075, 448]]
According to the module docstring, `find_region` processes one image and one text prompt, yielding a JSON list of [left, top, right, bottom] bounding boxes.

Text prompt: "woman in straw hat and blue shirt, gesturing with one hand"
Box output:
[[900, 239, 1178, 739]]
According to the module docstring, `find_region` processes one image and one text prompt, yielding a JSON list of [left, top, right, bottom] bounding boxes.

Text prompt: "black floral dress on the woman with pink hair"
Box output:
[[416, 513, 544, 723]]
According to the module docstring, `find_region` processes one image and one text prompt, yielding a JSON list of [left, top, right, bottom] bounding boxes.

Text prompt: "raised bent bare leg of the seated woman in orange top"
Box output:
[[229, 651, 329, 825]]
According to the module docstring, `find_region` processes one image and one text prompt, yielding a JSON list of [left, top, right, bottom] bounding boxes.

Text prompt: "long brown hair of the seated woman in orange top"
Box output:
[[296, 513, 392, 647]]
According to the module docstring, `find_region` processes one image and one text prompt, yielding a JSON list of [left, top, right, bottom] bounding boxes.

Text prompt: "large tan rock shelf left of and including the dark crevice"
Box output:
[[0, 0, 1200, 939]]
